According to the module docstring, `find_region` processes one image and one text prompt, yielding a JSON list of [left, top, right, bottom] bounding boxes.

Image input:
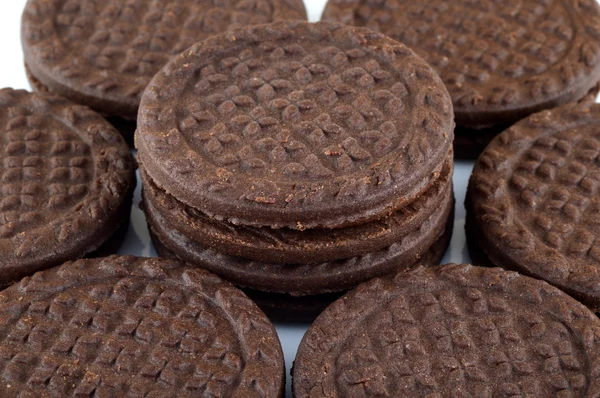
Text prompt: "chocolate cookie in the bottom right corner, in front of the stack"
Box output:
[[292, 264, 600, 398]]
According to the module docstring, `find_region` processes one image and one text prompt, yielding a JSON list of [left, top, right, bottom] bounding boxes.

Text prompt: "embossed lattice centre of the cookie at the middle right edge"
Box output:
[[511, 126, 600, 261]]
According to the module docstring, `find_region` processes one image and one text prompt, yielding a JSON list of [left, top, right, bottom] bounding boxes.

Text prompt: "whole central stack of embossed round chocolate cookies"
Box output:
[[136, 22, 453, 302]]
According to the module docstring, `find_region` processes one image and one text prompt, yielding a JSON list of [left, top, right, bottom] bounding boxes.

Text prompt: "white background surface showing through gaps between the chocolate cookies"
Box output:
[[0, 0, 506, 397]]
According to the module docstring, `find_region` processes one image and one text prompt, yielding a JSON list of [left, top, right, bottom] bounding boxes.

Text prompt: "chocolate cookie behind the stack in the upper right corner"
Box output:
[[323, 0, 600, 155]]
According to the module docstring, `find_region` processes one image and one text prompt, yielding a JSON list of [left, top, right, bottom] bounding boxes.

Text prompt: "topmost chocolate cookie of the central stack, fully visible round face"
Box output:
[[136, 22, 454, 230]]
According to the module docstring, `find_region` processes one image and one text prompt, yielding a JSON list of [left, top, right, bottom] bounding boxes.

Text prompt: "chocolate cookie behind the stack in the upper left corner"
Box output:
[[21, 0, 306, 140]]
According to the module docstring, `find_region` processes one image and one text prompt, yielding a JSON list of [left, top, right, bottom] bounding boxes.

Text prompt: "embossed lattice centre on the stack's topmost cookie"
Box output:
[[179, 42, 409, 181]]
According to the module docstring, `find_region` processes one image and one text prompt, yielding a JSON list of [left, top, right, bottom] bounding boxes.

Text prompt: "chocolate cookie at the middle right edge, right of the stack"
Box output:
[[466, 99, 600, 310]]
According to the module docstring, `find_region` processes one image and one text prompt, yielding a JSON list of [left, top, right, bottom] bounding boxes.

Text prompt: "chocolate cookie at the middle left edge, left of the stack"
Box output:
[[0, 89, 136, 286]]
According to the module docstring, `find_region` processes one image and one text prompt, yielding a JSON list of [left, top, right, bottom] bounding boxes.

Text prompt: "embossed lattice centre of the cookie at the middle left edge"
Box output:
[[0, 98, 94, 238]]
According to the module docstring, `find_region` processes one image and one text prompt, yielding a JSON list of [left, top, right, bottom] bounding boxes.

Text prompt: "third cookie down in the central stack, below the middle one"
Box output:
[[142, 183, 454, 296]]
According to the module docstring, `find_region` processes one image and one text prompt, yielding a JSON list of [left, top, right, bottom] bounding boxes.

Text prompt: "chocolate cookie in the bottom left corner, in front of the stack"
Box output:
[[0, 256, 285, 398]]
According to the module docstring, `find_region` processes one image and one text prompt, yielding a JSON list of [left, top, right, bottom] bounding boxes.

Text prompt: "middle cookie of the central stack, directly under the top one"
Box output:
[[140, 154, 453, 264]]
